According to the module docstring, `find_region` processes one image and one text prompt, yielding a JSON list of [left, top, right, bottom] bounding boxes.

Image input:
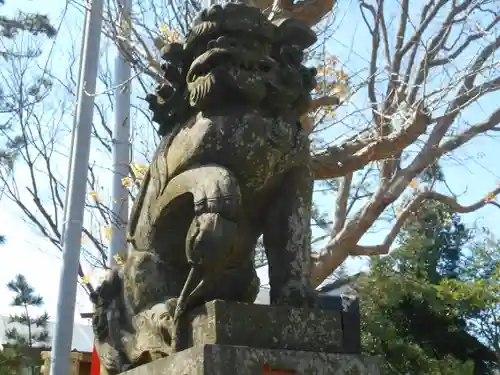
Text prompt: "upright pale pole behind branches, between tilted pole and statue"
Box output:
[[108, 0, 132, 266]]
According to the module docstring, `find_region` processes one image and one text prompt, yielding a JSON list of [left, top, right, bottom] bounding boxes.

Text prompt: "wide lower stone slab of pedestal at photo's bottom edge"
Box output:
[[120, 345, 379, 375]]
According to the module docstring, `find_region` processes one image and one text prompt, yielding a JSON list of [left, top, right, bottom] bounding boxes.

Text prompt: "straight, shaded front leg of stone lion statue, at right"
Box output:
[[263, 167, 314, 307]]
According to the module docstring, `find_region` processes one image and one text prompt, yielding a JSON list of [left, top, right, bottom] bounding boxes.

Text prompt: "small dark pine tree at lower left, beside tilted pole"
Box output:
[[5, 275, 49, 375]]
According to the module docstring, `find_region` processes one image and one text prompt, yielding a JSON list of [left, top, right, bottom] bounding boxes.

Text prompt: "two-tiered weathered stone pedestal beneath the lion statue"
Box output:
[[125, 301, 379, 375]]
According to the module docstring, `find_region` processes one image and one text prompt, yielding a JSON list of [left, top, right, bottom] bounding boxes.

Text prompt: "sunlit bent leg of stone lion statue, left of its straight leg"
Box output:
[[152, 164, 241, 352]]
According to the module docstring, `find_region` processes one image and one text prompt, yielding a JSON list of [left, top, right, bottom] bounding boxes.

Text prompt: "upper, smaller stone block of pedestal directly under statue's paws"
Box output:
[[189, 301, 345, 353]]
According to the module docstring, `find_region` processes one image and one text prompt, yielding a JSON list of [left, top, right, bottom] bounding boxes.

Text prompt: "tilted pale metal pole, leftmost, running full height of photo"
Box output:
[[50, 0, 103, 375]]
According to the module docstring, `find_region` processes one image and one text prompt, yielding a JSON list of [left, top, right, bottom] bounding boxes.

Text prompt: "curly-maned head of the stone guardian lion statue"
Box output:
[[146, 3, 316, 136]]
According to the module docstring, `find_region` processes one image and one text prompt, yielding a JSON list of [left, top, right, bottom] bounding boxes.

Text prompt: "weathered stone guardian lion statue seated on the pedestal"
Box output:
[[92, 3, 316, 374]]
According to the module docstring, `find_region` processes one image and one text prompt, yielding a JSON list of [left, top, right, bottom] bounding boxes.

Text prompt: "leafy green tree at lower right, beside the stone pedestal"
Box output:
[[358, 204, 500, 375]]
